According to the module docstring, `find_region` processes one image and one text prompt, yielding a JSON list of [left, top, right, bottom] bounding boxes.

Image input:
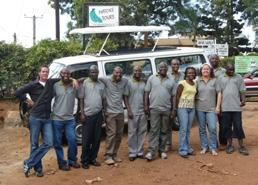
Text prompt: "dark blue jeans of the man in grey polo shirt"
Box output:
[[53, 119, 77, 167]]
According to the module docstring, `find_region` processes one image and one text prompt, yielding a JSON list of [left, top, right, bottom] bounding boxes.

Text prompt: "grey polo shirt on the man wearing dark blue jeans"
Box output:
[[52, 81, 77, 121]]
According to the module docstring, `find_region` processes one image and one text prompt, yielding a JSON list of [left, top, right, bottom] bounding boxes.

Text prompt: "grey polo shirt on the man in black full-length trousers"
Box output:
[[79, 78, 105, 116]]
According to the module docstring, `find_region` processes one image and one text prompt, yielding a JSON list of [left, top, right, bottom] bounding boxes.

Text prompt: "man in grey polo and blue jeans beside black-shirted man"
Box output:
[[52, 68, 80, 171]]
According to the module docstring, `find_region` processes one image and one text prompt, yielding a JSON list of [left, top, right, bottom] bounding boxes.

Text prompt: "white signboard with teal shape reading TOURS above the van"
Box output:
[[87, 5, 119, 27]]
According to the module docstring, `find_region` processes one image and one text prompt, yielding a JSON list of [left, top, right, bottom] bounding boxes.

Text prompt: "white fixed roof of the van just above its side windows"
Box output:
[[54, 47, 203, 65]]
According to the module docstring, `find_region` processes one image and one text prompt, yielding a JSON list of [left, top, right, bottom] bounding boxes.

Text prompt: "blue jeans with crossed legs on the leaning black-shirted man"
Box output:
[[25, 116, 53, 172]]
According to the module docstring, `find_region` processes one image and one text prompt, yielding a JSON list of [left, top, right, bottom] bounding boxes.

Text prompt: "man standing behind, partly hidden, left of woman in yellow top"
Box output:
[[166, 58, 185, 151]]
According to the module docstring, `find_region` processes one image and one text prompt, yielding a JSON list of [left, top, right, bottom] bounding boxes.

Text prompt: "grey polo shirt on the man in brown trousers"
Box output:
[[99, 76, 128, 113]]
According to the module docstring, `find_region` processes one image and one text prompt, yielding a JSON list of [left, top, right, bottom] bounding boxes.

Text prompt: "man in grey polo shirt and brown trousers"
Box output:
[[100, 67, 128, 165]]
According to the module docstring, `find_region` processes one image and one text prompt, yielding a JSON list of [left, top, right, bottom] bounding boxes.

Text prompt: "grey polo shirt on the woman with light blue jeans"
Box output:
[[196, 78, 220, 112]]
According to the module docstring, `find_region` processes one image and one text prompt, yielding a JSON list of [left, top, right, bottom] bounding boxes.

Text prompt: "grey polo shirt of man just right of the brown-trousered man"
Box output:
[[125, 78, 145, 115]]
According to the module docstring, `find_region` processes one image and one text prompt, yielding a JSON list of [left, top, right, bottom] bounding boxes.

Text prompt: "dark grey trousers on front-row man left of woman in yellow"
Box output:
[[148, 110, 170, 155]]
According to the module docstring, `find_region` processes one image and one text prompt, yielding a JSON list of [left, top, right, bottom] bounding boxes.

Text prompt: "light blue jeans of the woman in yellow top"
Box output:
[[177, 108, 195, 155]]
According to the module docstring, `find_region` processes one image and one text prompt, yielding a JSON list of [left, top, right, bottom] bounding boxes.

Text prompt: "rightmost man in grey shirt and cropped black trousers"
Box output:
[[219, 63, 249, 155]]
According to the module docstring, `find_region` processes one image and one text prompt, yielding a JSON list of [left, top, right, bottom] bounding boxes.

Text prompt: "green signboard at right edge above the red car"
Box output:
[[235, 56, 258, 73]]
